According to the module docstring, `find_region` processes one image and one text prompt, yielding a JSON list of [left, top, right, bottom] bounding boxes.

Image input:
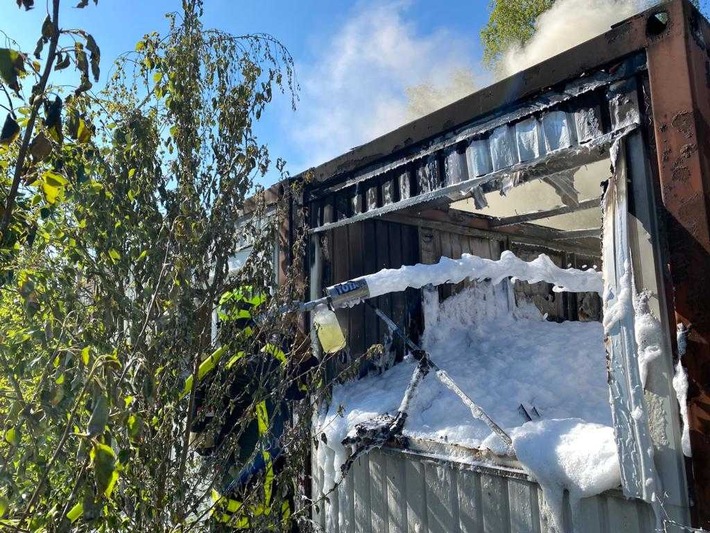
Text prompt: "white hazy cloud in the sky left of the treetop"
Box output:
[[284, 1, 482, 170]]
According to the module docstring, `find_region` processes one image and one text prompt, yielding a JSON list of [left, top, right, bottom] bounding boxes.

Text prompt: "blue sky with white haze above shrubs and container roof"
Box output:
[[0, 0, 488, 185]]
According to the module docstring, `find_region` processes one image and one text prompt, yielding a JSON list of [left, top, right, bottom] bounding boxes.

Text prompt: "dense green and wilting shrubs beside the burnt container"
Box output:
[[0, 0, 336, 531]]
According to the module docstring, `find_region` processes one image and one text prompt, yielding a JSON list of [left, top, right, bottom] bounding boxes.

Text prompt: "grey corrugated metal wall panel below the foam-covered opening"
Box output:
[[313, 450, 655, 533]]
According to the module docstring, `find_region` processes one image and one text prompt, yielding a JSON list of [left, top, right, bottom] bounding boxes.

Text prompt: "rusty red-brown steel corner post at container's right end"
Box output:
[[648, 1, 710, 529]]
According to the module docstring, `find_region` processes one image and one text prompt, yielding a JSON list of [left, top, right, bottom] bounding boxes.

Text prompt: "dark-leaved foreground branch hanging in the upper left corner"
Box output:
[[0, 0, 101, 272]]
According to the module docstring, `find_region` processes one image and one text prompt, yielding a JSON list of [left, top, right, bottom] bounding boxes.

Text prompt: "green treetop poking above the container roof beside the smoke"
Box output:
[[481, 0, 555, 66]]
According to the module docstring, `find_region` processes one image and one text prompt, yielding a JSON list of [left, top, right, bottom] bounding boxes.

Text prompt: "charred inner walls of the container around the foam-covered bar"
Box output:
[[320, 212, 601, 375]]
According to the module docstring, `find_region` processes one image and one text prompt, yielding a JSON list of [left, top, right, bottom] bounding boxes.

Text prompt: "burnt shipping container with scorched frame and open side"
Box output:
[[275, 0, 710, 531]]
